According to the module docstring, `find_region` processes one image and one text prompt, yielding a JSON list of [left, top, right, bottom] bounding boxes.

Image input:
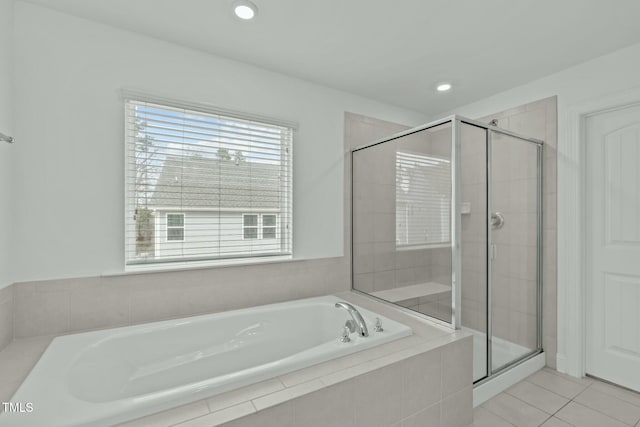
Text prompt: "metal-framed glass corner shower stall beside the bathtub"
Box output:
[[351, 116, 543, 383]]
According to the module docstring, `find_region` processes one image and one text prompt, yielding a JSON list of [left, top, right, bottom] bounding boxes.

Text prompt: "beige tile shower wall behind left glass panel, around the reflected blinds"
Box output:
[[346, 115, 451, 321]]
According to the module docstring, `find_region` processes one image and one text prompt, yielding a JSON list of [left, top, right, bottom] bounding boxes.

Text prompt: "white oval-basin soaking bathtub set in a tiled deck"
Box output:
[[0, 296, 412, 427]]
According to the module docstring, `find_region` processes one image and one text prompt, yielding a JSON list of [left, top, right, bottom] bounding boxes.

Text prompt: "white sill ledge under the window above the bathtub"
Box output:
[[101, 255, 302, 277]]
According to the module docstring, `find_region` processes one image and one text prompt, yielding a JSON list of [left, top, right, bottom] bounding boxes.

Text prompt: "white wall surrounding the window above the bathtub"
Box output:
[[12, 2, 424, 281]]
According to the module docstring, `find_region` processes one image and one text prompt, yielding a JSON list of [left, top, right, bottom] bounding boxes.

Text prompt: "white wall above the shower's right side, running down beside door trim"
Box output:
[[442, 44, 640, 369]]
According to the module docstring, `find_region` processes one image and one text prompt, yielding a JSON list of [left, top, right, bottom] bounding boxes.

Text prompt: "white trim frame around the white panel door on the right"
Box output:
[[557, 87, 640, 377]]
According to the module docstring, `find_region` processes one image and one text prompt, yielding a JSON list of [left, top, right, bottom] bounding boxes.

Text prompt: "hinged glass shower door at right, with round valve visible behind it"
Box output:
[[489, 131, 541, 372]]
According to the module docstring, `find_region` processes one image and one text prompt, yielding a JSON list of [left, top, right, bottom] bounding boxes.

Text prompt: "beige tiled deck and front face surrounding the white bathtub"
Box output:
[[0, 292, 472, 427]]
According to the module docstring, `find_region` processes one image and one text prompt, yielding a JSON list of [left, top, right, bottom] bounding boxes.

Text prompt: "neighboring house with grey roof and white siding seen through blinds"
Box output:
[[138, 155, 287, 259]]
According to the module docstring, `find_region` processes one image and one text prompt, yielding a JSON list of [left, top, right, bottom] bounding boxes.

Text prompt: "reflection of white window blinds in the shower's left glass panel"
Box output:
[[396, 151, 451, 247]]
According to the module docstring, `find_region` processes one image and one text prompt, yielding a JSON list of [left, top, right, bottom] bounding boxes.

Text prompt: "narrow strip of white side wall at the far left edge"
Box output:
[[0, 0, 15, 288]]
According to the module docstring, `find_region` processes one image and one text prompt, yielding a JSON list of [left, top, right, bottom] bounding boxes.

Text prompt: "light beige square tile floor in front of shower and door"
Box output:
[[471, 368, 640, 427]]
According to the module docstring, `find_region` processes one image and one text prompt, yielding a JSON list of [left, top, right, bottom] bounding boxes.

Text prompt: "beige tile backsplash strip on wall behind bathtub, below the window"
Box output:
[[5, 257, 349, 339]]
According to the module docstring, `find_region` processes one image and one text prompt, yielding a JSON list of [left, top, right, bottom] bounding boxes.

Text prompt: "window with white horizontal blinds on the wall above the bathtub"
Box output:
[[125, 98, 293, 265]]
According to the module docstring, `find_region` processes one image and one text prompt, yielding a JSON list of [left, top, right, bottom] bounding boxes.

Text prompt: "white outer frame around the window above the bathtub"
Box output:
[[120, 89, 298, 272]]
